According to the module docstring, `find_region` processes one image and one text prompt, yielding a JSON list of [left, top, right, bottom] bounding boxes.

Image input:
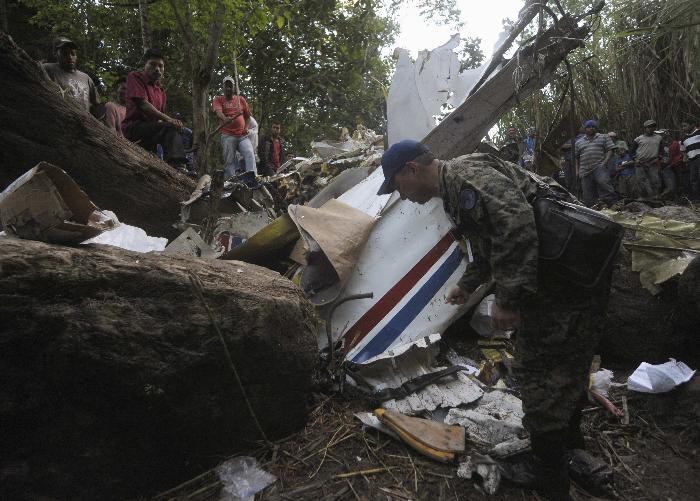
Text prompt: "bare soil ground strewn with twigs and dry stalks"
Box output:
[[157, 369, 700, 501]]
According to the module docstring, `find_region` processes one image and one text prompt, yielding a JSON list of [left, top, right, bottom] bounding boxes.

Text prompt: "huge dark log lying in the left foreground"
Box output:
[[0, 238, 317, 499]]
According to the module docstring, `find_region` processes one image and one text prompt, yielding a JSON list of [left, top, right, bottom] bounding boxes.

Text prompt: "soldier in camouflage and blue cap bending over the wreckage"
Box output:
[[378, 140, 609, 499]]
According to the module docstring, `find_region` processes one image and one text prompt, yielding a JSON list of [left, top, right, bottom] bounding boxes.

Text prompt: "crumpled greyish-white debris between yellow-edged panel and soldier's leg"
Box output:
[[445, 390, 524, 448]]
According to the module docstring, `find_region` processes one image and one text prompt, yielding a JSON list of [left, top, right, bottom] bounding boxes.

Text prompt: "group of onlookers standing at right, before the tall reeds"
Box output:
[[500, 120, 700, 207]]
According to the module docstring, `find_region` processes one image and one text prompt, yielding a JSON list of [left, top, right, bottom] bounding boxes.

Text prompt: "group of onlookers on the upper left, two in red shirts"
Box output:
[[42, 37, 287, 177]]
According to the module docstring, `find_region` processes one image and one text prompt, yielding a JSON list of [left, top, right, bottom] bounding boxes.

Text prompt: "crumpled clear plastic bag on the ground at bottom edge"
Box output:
[[216, 456, 277, 501]]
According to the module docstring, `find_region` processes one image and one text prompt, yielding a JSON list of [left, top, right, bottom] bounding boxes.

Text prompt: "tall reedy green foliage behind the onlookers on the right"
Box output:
[[496, 0, 700, 153]]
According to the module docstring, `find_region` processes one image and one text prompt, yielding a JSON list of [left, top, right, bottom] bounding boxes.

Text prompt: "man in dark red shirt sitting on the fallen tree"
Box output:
[[122, 49, 185, 167]]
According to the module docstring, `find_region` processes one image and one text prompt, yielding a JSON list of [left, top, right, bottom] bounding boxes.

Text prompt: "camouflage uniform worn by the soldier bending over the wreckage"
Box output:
[[440, 153, 609, 456]]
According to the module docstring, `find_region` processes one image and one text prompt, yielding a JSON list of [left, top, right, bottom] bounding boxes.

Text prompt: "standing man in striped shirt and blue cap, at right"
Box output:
[[576, 120, 616, 207]]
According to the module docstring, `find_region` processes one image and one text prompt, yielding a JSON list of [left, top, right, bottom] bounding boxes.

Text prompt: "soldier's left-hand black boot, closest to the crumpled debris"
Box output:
[[500, 431, 571, 501]]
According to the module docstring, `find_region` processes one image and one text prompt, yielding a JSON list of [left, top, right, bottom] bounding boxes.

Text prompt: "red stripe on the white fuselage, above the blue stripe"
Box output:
[[344, 233, 455, 353]]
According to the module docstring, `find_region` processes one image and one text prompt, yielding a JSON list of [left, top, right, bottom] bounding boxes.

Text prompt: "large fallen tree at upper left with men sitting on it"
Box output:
[[0, 32, 195, 238]]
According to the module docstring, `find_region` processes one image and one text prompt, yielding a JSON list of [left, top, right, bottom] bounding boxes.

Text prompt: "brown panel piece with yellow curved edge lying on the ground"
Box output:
[[374, 409, 464, 463]]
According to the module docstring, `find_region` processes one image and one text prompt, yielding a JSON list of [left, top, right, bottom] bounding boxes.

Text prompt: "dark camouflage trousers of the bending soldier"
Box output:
[[514, 285, 609, 436]]
